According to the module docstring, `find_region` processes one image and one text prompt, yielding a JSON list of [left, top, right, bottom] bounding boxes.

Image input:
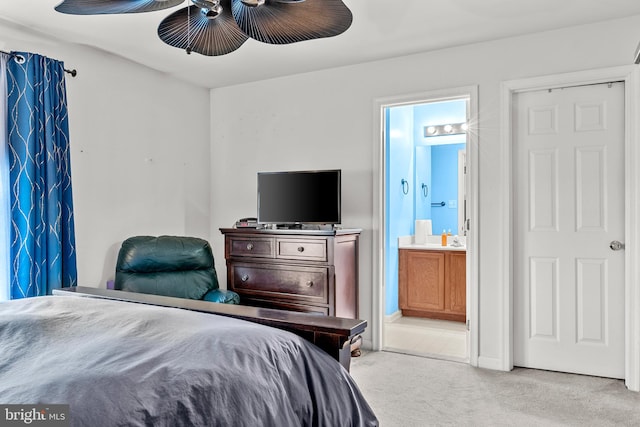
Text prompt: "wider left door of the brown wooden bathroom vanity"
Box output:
[[398, 249, 445, 316]]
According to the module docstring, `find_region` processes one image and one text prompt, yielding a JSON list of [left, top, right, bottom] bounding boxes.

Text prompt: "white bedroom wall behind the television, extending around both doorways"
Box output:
[[211, 16, 640, 366]]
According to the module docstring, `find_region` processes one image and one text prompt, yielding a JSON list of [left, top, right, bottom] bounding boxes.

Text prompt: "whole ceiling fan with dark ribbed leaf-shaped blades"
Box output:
[[55, 0, 353, 56]]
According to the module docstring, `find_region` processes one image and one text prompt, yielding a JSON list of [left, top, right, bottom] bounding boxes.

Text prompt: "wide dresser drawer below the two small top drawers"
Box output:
[[228, 263, 329, 304]]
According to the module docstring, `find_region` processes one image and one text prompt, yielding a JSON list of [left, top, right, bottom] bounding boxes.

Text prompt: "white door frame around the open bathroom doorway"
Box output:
[[371, 86, 478, 366]]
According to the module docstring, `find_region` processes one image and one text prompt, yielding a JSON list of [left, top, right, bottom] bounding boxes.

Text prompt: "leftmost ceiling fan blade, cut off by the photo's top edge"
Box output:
[[55, 0, 184, 15]]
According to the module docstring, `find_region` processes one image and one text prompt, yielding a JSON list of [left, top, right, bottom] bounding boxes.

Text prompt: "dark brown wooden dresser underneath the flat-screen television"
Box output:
[[220, 228, 361, 319]]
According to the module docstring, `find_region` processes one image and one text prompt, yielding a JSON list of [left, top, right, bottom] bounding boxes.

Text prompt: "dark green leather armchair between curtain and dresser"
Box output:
[[114, 236, 240, 304]]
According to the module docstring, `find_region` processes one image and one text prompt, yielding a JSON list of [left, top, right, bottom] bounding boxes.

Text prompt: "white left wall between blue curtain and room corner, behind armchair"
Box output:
[[0, 21, 210, 288]]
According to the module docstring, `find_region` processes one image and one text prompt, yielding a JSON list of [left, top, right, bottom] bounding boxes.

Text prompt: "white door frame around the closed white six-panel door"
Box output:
[[500, 66, 640, 391]]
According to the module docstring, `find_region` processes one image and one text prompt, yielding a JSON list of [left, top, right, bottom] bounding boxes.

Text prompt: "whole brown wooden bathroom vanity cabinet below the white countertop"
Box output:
[[398, 248, 467, 322]]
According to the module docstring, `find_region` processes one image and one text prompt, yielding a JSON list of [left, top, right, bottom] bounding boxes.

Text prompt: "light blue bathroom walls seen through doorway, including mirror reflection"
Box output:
[[385, 100, 466, 315]]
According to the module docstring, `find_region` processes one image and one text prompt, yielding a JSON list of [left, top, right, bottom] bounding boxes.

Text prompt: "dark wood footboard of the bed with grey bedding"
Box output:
[[53, 286, 367, 371]]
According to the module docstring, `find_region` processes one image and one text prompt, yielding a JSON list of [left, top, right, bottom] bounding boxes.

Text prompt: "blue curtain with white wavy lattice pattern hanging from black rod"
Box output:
[[7, 52, 77, 299]]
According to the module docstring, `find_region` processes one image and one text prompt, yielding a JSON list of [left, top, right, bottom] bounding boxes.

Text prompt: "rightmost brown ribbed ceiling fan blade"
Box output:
[[232, 0, 353, 44]]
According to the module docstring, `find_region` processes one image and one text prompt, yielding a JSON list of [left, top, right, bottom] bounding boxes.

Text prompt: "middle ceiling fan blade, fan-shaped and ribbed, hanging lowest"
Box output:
[[158, 0, 249, 56]]
